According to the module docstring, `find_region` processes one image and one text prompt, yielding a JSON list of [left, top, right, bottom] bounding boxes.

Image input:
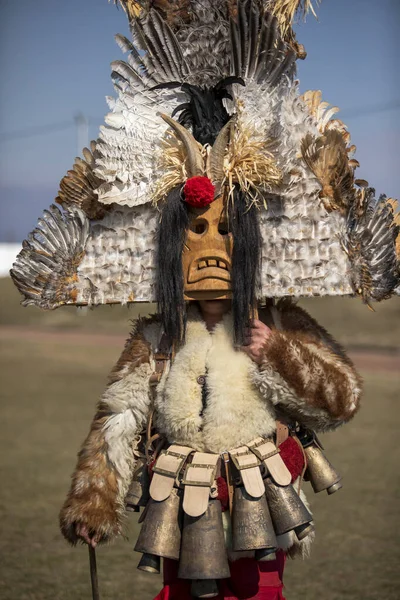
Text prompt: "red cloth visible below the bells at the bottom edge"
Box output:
[[154, 551, 285, 600]]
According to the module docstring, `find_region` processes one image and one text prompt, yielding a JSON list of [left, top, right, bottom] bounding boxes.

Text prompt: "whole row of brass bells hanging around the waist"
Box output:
[[127, 435, 342, 598]]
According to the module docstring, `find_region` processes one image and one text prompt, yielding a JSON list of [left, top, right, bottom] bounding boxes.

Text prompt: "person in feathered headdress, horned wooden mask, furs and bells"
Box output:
[[12, 0, 399, 600]]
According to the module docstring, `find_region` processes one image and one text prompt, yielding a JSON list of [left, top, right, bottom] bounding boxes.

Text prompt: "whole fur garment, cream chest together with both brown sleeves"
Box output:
[[60, 302, 361, 545]]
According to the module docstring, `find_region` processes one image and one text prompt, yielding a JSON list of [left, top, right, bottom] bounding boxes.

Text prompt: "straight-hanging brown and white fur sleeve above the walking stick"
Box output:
[[60, 320, 157, 544]]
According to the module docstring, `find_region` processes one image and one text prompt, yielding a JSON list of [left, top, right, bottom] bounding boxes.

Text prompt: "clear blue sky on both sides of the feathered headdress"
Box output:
[[0, 0, 400, 241]]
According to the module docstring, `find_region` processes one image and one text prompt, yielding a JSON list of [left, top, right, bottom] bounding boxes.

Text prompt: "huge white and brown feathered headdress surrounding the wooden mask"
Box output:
[[11, 0, 399, 308]]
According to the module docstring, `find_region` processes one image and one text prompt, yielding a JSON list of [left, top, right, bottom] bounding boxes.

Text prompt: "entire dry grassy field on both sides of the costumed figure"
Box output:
[[0, 280, 400, 600]]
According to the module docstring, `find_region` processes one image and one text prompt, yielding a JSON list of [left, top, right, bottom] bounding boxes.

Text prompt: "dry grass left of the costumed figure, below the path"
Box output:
[[0, 337, 160, 600]]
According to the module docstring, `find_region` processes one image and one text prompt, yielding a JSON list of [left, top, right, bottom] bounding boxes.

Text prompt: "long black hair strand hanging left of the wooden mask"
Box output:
[[157, 186, 189, 343]]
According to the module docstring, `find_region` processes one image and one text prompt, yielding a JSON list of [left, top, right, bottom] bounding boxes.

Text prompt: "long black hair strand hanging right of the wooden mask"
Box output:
[[228, 188, 261, 344]]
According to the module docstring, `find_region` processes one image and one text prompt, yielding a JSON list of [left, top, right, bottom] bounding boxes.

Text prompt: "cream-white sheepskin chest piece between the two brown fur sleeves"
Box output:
[[155, 308, 276, 453]]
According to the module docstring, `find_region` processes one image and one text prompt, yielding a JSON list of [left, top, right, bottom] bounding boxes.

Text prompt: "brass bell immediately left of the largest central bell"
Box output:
[[135, 488, 182, 560]]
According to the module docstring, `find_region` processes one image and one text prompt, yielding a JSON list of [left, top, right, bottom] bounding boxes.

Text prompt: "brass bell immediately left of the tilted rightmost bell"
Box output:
[[264, 477, 312, 538]]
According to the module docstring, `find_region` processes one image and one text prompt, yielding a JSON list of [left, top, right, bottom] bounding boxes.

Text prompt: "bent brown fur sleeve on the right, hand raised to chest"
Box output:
[[253, 302, 361, 431]]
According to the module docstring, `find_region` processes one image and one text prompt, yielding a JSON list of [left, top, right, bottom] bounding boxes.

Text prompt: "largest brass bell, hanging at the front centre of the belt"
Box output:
[[178, 499, 230, 579]]
